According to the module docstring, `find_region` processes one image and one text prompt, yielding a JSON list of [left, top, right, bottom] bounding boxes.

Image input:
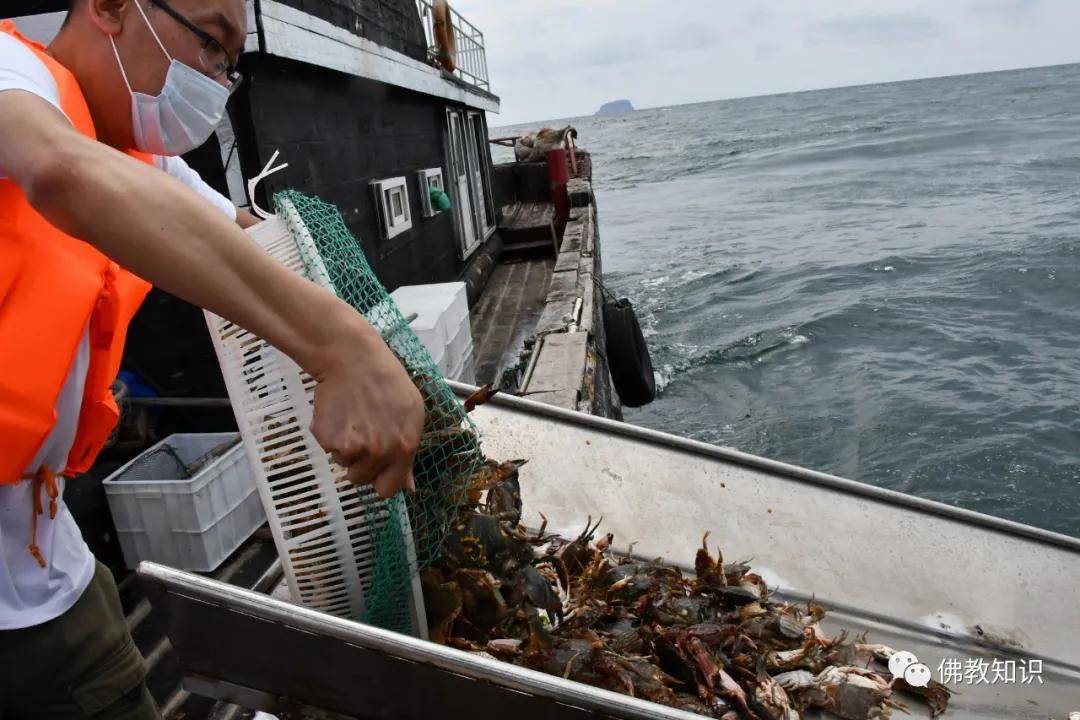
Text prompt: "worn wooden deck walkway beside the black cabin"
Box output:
[[471, 256, 555, 384]]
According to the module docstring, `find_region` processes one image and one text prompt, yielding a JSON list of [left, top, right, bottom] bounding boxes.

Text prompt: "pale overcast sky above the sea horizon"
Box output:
[[453, 0, 1080, 126]]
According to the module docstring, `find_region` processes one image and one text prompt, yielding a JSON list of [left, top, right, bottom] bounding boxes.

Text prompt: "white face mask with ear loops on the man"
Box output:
[[109, 2, 229, 155]]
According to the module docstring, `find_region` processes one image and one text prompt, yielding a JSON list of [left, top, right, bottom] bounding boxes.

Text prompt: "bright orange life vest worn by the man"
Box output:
[[0, 21, 153, 485]]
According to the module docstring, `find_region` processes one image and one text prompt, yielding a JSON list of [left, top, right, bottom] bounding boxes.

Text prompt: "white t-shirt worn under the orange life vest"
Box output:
[[0, 33, 237, 630]]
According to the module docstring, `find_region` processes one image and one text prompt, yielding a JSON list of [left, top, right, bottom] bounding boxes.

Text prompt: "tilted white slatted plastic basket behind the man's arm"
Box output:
[[206, 202, 428, 638]]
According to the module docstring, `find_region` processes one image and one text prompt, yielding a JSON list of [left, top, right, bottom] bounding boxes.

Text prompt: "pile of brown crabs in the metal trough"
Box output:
[[422, 390, 950, 720]]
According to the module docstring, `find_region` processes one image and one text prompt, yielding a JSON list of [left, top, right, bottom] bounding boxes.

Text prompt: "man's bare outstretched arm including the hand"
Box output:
[[0, 91, 423, 497]]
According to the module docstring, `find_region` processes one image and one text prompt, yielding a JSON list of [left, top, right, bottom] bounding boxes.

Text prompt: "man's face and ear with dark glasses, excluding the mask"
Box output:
[[102, 0, 247, 129]]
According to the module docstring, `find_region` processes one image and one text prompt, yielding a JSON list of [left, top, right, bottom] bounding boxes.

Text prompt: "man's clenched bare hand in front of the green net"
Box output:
[[311, 317, 424, 498]]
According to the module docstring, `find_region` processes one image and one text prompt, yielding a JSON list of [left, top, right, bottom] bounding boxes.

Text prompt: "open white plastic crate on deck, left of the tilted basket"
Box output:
[[103, 433, 266, 572]]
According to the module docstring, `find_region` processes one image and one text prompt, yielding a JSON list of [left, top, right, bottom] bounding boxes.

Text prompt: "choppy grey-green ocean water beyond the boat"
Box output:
[[492, 65, 1080, 536]]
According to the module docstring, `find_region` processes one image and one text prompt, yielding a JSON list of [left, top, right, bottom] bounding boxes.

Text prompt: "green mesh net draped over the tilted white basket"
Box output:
[[274, 190, 484, 633]]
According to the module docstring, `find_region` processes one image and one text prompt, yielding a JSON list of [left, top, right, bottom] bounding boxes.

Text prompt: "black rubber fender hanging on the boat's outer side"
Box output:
[[604, 298, 657, 408]]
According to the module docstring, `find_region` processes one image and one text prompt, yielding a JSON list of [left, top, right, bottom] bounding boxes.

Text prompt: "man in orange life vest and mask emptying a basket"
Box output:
[[0, 0, 423, 720]]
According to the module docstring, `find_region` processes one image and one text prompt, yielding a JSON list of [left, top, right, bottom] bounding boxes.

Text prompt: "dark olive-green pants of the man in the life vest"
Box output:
[[0, 562, 161, 720]]
